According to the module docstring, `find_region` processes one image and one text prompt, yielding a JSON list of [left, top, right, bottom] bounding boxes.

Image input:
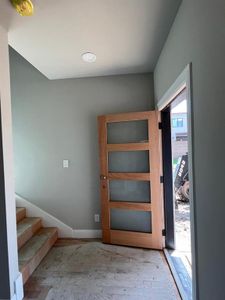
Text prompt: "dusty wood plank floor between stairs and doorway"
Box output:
[[24, 240, 180, 300]]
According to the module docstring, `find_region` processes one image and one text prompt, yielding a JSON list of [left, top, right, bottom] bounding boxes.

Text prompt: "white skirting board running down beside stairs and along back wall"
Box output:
[[15, 194, 102, 239]]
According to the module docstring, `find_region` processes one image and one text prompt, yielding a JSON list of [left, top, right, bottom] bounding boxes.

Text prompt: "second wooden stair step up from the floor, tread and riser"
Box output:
[[17, 217, 42, 249]]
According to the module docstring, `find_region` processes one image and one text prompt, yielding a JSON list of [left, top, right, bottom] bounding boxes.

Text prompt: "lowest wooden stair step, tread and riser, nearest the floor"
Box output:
[[19, 227, 58, 283]]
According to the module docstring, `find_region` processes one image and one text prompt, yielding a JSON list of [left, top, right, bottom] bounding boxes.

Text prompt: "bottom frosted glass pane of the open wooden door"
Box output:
[[110, 208, 152, 233]]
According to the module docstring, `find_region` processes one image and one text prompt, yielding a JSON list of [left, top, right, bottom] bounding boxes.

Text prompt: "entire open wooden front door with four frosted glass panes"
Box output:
[[98, 111, 164, 249]]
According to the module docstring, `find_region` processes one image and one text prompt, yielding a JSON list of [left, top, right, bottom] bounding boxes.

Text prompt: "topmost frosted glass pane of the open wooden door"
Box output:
[[107, 120, 148, 144]]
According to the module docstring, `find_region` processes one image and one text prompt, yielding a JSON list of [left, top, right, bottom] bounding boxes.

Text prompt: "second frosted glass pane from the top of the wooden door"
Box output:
[[108, 151, 149, 173]]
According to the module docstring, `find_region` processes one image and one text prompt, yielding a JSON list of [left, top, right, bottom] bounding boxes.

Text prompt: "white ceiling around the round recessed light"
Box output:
[[0, 0, 181, 79]]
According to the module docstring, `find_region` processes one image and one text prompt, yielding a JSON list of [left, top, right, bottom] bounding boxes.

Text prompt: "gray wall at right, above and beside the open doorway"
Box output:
[[154, 0, 225, 300]]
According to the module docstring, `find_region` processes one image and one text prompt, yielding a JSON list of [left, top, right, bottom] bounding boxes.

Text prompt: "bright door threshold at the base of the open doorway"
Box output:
[[164, 249, 192, 300]]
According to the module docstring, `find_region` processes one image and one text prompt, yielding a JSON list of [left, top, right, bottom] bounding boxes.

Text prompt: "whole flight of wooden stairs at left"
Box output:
[[16, 207, 58, 284]]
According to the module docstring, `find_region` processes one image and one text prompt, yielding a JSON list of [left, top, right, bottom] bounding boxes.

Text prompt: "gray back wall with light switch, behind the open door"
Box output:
[[10, 49, 154, 229]]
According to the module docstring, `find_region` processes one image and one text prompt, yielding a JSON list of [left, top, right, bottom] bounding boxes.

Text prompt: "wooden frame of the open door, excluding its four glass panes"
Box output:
[[98, 111, 164, 249]]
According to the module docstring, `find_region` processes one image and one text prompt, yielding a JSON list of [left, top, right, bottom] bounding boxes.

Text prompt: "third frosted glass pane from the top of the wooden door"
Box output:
[[109, 180, 151, 203]]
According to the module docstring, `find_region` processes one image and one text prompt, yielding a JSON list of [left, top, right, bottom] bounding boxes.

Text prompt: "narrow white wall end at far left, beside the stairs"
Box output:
[[0, 26, 22, 299]]
